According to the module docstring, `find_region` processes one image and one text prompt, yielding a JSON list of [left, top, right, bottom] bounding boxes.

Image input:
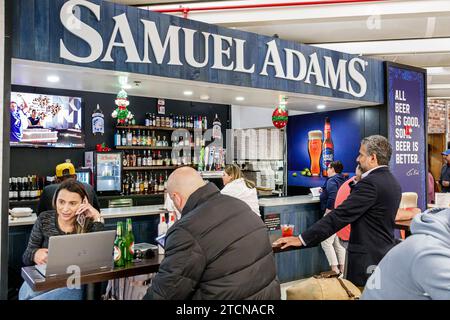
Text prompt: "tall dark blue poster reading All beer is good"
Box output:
[[386, 64, 427, 210]]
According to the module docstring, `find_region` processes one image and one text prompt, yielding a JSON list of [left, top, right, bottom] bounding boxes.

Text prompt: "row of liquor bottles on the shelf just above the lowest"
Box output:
[[122, 150, 198, 168]]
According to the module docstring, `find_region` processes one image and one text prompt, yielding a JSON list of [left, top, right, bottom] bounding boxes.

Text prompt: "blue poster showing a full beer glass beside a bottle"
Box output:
[[287, 109, 361, 188]]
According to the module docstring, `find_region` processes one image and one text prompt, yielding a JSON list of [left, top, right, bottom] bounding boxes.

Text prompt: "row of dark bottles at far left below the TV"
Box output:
[[9, 175, 45, 201]]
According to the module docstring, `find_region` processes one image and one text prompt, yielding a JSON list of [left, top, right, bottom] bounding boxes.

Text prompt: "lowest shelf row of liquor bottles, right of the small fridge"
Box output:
[[122, 171, 168, 195]]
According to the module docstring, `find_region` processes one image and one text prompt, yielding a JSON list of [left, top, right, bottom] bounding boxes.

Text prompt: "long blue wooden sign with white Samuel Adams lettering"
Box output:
[[13, 0, 384, 103]]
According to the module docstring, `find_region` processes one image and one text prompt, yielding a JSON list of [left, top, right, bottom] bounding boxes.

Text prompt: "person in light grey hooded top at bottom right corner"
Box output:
[[361, 208, 450, 300]]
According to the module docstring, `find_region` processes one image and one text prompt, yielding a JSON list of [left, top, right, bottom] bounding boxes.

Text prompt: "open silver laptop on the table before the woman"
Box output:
[[36, 230, 116, 277]]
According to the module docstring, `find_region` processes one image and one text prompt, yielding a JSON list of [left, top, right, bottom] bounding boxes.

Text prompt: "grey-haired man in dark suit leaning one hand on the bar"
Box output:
[[274, 135, 401, 287]]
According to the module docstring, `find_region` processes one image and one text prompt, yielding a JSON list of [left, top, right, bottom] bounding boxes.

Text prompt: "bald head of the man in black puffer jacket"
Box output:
[[167, 167, 206, 212]]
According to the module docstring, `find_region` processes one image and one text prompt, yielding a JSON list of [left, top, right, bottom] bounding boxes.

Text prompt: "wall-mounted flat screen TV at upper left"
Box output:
[[10, 92, 85, 148]]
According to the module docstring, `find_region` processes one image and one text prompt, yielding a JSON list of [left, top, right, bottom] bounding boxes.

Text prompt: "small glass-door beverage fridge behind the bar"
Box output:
[[84, 151, 122, 195]]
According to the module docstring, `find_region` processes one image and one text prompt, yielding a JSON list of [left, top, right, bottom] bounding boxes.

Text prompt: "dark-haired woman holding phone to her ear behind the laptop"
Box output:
[[19, 179, 104, 300]]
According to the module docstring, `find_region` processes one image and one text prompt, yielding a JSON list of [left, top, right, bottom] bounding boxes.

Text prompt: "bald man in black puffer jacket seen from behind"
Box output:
[[144, 167, 280, 300]]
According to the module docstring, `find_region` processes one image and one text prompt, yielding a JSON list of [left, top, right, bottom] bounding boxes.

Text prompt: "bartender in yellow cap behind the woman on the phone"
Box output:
[[37, 160, 100, 216]]
